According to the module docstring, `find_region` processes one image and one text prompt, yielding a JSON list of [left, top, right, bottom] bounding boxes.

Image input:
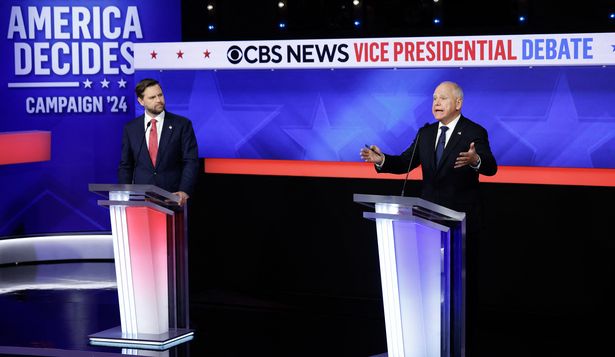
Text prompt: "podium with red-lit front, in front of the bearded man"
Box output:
[[89, 184, 194, 350]]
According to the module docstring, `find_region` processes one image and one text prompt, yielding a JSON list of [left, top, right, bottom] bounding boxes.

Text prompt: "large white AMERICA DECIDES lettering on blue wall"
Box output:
[[7, 6, 143, 76]]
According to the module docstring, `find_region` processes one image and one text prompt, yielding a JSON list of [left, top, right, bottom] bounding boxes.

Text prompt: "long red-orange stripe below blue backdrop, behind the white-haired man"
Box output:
[[205, 159, 615, 187]]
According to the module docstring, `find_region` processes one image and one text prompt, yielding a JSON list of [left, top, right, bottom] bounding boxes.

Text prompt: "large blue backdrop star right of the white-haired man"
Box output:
[[499, 75, 615, 167]]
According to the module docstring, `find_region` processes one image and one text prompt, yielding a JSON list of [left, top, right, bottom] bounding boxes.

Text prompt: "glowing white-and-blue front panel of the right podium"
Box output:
[[376, 214, 450, 357]]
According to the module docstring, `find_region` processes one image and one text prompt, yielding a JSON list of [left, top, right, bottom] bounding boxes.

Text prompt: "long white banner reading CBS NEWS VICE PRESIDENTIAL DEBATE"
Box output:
[[135, 33, 615, 69]]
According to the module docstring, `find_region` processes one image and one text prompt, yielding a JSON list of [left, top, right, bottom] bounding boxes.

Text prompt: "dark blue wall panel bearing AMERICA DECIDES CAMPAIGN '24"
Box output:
[[0, 0, 181, 236]]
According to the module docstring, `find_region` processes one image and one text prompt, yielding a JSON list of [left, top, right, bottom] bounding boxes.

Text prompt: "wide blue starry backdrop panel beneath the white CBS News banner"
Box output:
[[136, 67, 615, 168]]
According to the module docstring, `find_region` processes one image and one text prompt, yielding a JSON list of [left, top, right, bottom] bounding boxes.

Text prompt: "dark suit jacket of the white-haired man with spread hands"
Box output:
[[379, 115, 498, 213]]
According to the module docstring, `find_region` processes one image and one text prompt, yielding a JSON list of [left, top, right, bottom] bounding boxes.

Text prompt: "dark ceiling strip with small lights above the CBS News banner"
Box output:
[[182, 0, 615, 41]]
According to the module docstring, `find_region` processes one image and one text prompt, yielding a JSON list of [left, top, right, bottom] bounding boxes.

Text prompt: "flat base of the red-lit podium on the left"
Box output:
[[88, 326, 194, 350]]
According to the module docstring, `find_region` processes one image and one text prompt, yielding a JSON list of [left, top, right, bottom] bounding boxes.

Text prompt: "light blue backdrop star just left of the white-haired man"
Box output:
[[284, 94, 362, 161]]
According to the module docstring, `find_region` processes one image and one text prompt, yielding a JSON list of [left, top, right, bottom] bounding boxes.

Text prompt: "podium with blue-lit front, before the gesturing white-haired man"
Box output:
[[354, 194, 465, 357]]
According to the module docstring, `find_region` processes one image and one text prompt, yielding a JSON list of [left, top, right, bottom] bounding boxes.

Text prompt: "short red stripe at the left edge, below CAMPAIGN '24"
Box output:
[[0, 131, 51, 165]]
